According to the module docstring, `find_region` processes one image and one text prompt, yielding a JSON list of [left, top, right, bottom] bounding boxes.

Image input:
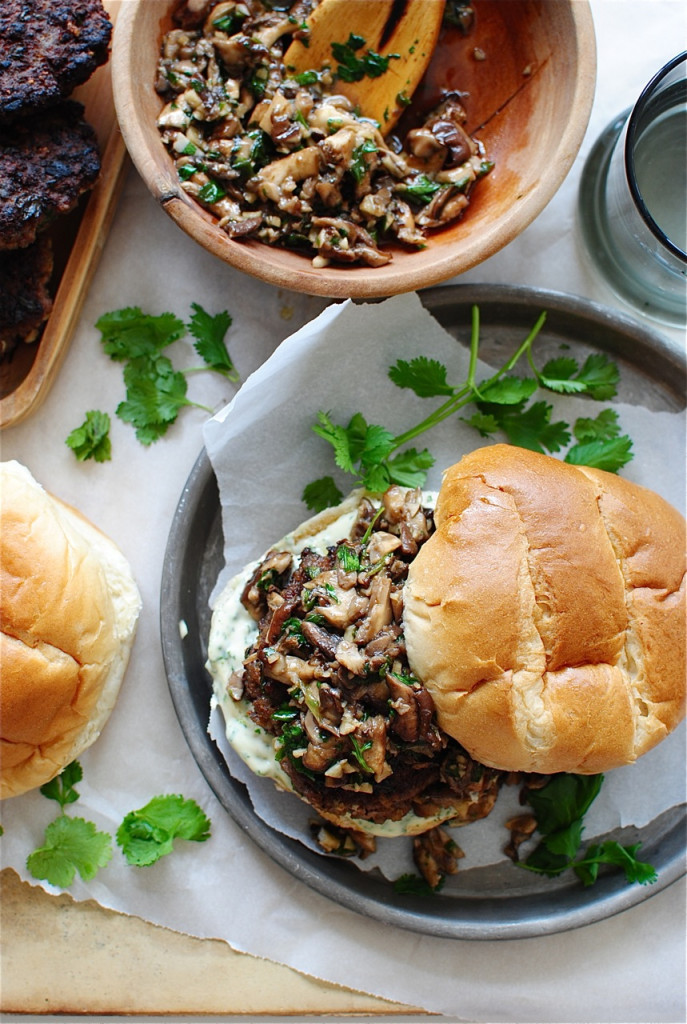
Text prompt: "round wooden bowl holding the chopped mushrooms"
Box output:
[[113, 0, 596, 298]]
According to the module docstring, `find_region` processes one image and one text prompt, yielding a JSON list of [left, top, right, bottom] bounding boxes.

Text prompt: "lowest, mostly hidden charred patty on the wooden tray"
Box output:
[[0, 238, 52, 359]]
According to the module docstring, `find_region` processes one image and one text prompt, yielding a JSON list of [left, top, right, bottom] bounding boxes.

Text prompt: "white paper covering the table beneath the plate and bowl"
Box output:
[[2, 0, 686, 1022]]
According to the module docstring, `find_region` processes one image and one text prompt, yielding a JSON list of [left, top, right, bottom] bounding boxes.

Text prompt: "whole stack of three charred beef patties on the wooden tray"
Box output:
[[0, 0, 112, 359]]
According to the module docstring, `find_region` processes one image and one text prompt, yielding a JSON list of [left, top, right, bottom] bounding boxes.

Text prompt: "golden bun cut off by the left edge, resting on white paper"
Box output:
[[0, 462, 140, 799]]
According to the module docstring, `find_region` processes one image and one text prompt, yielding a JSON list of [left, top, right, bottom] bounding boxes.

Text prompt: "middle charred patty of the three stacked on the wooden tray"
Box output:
[[0, 99, 100, 250]]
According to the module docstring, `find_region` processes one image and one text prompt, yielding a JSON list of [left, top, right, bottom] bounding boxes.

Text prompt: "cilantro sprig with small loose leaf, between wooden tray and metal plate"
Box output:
[[67, 302, 239, 462]]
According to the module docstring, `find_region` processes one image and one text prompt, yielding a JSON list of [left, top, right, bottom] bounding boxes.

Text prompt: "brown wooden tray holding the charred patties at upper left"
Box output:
[[0, 0, 126, 428]]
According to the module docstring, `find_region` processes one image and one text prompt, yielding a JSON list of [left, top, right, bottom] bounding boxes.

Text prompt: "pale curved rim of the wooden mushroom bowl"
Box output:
[[112, 0, 597, 299]]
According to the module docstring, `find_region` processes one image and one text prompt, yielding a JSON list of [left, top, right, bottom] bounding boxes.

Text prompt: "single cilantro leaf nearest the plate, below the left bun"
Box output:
[[116, 796, 210, 867]]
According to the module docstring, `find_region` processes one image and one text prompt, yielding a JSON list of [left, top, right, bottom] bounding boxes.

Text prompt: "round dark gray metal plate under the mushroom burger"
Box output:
[[161, 286, 687, 939]]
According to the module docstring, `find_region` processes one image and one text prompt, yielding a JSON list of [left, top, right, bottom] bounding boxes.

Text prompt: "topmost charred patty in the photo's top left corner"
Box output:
[[0, 0, 112, 123]]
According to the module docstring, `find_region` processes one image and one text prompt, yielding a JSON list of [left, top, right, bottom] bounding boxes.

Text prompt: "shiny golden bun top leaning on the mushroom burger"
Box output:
[[404, 444, 685, 774]]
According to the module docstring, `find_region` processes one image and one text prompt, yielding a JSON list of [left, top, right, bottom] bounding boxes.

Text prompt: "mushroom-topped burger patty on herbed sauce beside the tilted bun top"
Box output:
[[240, 486, 504, 823]]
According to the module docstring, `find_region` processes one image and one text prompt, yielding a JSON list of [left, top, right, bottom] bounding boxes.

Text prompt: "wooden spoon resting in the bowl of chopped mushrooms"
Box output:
[[284, 0, 445, 134]]
